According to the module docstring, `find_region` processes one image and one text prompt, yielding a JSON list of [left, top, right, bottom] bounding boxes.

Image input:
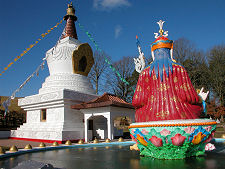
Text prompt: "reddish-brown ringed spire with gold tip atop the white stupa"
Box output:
[[62, 2, 78, 39]]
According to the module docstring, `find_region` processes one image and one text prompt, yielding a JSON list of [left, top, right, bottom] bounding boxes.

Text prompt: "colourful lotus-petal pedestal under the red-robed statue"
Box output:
[[129, 119, 216, 159]]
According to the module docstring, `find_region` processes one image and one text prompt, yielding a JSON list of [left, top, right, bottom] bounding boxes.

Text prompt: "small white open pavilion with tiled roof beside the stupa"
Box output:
[[72, 93, 135, 141]]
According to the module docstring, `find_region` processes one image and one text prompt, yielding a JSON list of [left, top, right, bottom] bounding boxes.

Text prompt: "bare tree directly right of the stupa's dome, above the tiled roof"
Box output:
[[88, 51, 110, 94]]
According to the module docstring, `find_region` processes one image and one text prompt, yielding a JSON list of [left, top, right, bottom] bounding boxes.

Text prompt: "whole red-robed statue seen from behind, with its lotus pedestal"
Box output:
[[129, 21, 216, 159]]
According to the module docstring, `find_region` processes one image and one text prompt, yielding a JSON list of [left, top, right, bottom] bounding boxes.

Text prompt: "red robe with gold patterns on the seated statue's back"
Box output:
[[132, 64, 202, 122]]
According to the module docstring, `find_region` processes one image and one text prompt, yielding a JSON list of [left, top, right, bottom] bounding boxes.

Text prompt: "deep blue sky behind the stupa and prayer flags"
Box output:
[[0, 0, 225, 96]]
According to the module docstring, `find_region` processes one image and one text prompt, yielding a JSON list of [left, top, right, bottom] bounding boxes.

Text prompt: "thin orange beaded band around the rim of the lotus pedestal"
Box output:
[[128, 122, 217, 128]]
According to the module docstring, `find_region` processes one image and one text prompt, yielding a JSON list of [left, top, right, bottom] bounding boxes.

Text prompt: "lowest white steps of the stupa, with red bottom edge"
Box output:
[[11, 122, 84, 142]]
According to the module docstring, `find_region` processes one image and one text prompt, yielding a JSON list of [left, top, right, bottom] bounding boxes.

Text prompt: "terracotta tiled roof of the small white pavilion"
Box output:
[[71, 93, 134, 109]]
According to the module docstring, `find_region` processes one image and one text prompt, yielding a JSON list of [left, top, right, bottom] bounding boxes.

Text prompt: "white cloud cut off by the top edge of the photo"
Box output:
[[93, 0, 131, 10]]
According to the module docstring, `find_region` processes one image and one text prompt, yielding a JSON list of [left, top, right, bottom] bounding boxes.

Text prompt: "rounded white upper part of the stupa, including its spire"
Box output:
[[39, 3, 95, 94]]
